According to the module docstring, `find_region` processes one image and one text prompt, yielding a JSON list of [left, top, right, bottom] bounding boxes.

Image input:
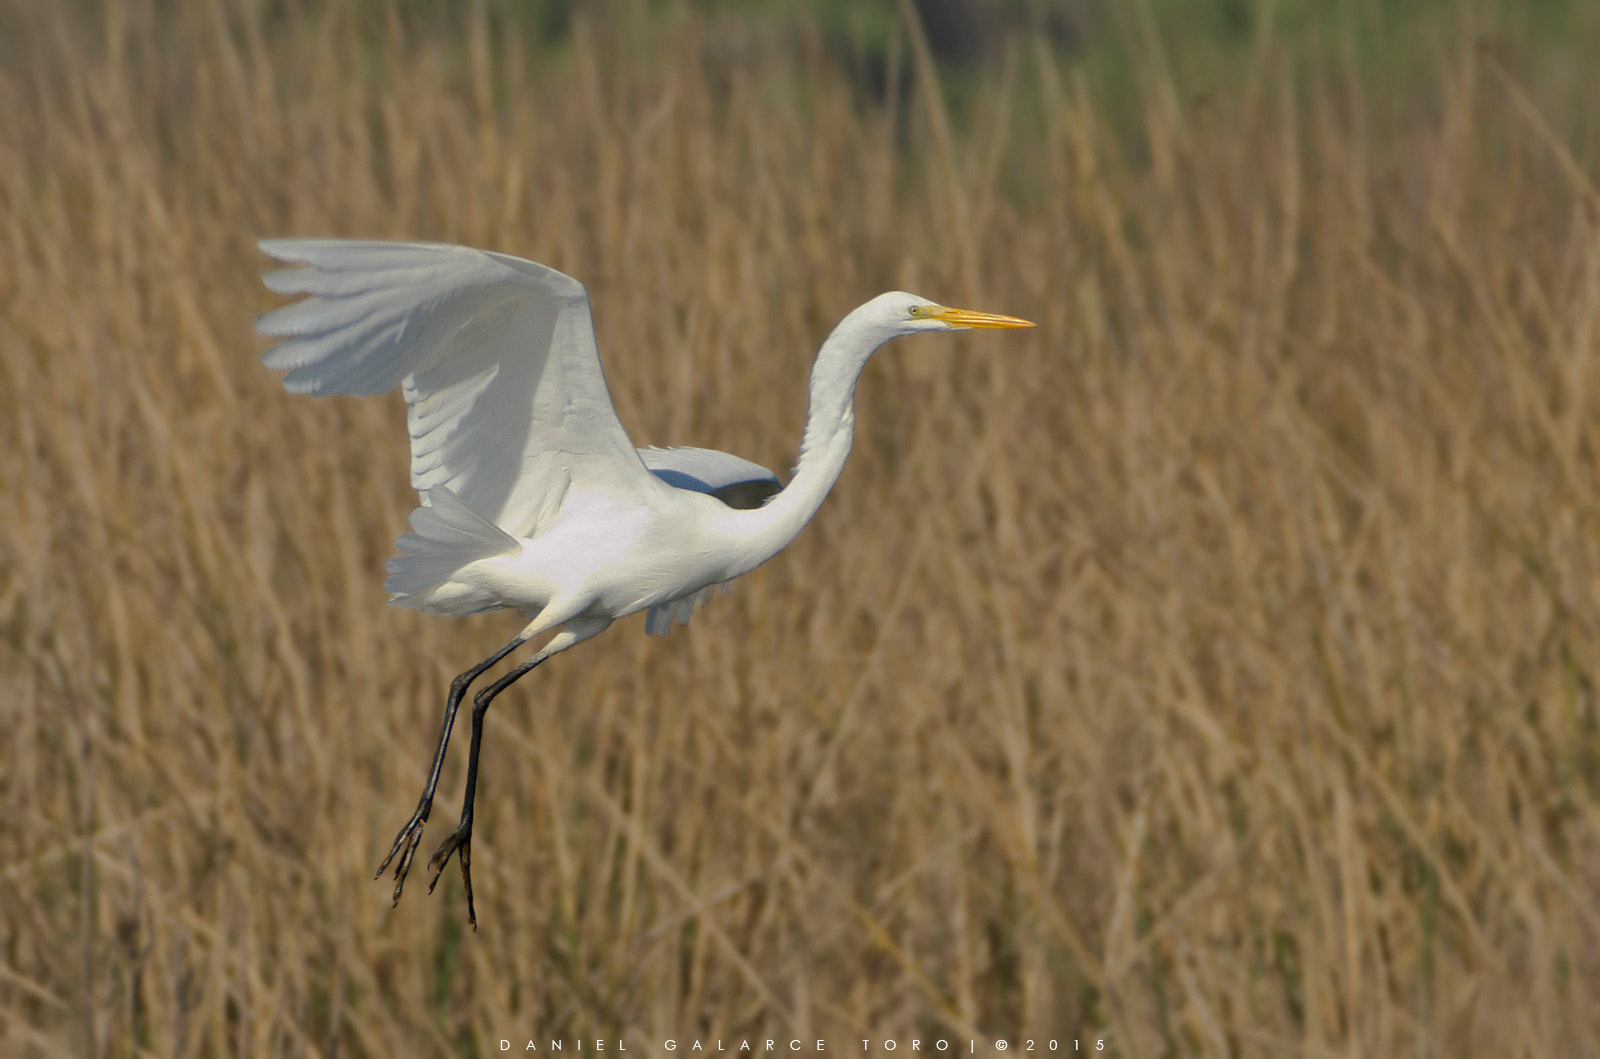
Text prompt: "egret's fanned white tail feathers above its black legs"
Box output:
[[384, 486, 520, 613]]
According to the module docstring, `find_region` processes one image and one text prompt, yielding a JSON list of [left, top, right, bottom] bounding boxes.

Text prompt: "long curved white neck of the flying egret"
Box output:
[[731, 310, 893, 576]]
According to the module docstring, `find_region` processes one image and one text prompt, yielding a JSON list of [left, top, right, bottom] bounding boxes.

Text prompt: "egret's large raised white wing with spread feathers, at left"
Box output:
[[256, 238, 654, 536]]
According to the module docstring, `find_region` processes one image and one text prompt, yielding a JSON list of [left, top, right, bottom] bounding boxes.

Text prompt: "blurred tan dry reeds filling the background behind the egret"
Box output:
[[0, 0, 1600, 1059]]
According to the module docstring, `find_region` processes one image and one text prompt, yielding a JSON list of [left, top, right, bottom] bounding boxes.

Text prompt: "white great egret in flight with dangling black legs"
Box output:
[[256, 238, 1034, 929]]
